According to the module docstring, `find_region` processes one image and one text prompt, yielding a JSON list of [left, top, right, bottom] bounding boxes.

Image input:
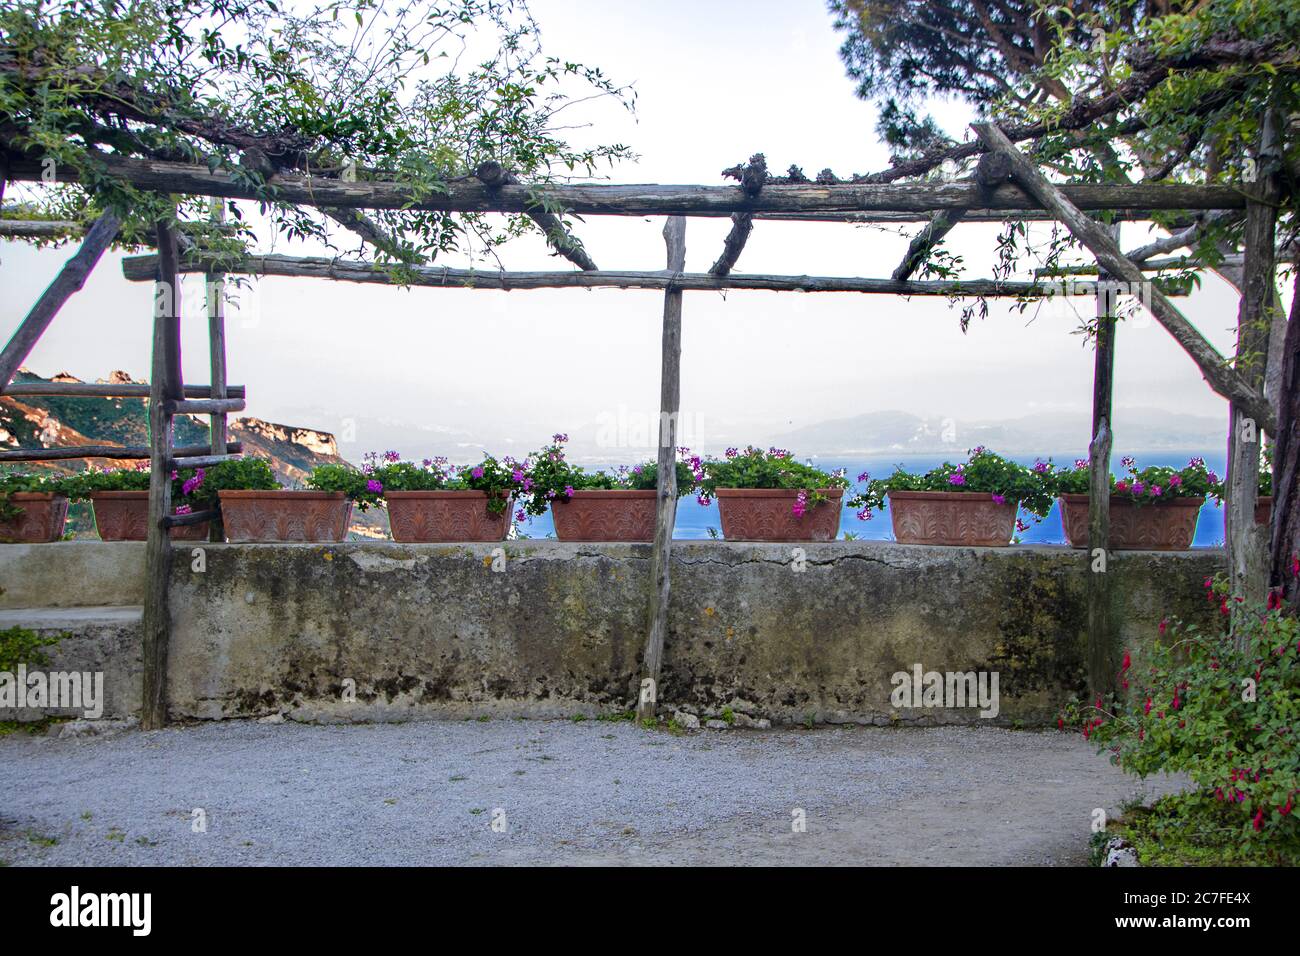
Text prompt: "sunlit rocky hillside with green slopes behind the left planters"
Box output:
[[0, 368, 378, 536]]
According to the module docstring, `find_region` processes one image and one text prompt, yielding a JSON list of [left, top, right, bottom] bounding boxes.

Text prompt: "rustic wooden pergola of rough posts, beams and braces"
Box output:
[[0, 124, 1277, 728]]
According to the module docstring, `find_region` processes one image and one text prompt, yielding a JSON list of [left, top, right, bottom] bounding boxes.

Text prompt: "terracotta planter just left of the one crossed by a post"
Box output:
[[889, 492, 1017, 548]]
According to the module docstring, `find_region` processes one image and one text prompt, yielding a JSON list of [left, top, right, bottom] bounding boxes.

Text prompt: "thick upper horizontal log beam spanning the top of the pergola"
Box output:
[[9, 155, 1245, 216]]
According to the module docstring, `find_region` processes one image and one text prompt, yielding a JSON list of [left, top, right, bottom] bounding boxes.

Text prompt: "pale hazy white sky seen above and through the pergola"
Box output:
[[0, 0, 1258, 458]]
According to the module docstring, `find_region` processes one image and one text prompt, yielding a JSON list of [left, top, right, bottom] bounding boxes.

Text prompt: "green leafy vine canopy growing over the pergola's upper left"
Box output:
[[0, 0, 632, 261]]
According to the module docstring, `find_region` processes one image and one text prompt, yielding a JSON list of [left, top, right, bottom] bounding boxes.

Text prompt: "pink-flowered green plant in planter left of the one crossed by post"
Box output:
[[849, 447, 1052, 531]]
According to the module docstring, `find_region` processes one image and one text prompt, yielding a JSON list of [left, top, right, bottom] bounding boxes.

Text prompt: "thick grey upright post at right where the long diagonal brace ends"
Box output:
[[1223, 109, 1282, 621]]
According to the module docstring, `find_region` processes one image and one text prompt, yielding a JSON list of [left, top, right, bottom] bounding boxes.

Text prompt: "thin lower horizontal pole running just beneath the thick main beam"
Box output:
[[122, 255, 1159, 298]]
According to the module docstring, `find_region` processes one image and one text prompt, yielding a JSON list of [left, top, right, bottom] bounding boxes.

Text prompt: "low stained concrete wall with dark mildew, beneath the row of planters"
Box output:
[[0, 541, 1222, 723]]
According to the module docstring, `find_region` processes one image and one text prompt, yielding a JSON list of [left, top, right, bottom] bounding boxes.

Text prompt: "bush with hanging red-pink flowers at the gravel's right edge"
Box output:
[[1082, 579, 1300, 852]]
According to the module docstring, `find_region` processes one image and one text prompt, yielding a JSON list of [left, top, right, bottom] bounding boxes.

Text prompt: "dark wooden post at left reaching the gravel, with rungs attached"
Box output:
[[140, 222, 183, 730]]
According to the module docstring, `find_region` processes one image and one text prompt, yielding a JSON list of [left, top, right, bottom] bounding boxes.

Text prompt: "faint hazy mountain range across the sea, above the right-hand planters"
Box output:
[[774, 407, 1227, 458]]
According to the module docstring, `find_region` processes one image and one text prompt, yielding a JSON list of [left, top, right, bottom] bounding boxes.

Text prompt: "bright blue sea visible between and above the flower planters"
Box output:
[[509, 450, 1226, 548]]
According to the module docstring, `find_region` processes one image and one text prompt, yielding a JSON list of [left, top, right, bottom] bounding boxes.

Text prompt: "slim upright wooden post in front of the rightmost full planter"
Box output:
[[1087, 247, 1119, 697]]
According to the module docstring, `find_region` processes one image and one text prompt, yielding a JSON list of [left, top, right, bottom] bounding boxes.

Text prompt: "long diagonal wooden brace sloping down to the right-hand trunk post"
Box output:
[[971, 122, 1273, 432]]
